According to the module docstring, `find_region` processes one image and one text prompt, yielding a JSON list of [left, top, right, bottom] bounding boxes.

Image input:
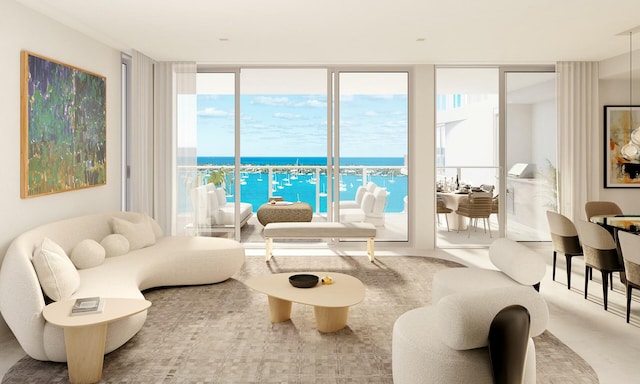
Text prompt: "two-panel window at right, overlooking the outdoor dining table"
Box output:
[[435, 67, 556, 247]]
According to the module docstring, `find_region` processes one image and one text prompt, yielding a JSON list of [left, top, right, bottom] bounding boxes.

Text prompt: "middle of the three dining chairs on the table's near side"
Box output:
[[576, 220, 624, 311]]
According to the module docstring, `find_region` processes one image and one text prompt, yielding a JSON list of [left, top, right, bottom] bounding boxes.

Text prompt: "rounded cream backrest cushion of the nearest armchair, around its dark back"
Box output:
[[436, 285, 549, 350]]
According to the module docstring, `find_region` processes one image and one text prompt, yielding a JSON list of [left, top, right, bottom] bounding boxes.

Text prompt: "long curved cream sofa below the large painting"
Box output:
[[0, 212, 245, 362]]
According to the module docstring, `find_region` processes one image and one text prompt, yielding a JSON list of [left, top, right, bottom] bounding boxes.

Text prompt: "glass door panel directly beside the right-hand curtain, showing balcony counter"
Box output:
[[503, 69, 557, 241]]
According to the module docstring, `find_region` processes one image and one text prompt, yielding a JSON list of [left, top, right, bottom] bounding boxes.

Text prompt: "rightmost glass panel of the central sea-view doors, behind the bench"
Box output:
[[333, 71, 409, 241]]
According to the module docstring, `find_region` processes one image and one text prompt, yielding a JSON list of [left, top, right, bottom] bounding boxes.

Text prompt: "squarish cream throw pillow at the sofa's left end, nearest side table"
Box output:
[[32, 237, 80, 301]]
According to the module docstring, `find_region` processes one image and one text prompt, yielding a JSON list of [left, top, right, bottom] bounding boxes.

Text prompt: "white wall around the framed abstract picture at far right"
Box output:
[[593, 80, 640, 213]]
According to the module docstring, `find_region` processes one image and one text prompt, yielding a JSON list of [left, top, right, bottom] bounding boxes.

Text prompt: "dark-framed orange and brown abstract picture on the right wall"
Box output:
[[604, 105, 640, 188]]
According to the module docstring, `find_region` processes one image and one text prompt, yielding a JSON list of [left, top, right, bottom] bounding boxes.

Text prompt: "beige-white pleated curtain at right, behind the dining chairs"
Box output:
[[556, 62, 602, 221]]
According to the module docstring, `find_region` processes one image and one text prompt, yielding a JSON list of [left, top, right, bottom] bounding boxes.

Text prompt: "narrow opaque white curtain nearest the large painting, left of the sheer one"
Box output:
[[128, 51, 154, 215]]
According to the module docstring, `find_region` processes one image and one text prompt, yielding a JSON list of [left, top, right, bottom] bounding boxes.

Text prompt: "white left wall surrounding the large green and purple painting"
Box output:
[[0, 0, 121, 341]]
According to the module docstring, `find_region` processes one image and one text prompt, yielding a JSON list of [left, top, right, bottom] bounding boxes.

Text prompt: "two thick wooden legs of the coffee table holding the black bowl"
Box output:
[[267, 295, 349, 333]]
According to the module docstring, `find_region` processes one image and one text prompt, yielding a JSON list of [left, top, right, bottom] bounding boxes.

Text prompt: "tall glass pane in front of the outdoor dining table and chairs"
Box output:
[[435, 68, 500, 247]]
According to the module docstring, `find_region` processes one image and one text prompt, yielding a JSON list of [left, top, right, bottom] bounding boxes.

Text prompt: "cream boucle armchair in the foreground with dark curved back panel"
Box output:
[[392, 285, 549, 384]]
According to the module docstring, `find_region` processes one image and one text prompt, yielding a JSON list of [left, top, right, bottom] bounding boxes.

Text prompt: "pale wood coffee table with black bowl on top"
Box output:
[[245, 272, 364, 333]]
